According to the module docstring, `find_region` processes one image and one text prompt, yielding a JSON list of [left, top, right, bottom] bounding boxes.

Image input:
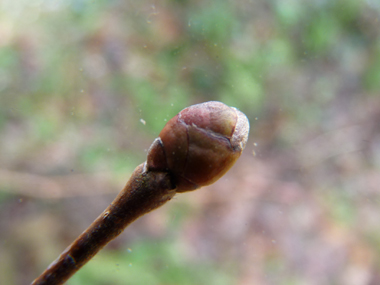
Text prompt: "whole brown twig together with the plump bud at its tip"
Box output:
[[32, 101, 249, 285]]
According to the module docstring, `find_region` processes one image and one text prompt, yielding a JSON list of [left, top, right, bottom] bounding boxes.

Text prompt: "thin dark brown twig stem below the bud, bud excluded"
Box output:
[[31, 163, 175, 285]]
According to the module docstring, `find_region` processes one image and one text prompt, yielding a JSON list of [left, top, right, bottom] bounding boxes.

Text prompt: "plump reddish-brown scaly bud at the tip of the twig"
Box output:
[[146, 101, 249, 192]]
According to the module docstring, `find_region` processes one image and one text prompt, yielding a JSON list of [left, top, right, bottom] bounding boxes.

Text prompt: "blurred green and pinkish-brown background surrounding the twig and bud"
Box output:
[[0, 0, 380, 285]]
